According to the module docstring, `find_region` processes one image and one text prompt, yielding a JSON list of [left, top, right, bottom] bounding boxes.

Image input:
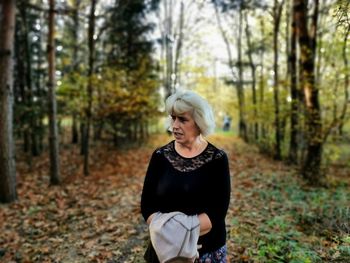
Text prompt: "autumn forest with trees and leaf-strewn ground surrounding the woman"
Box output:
[[0, 0, 350, 263]]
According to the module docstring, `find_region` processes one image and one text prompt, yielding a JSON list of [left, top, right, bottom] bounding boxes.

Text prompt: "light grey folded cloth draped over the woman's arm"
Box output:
[[149, 212, 200, 263]]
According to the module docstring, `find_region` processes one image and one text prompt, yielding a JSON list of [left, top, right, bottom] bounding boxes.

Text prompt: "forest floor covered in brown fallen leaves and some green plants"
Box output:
[[0, 135, 350, 263]]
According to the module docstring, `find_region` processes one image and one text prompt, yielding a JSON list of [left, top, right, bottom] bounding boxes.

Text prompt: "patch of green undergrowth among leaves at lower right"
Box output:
[[232, 174, 350, 263]]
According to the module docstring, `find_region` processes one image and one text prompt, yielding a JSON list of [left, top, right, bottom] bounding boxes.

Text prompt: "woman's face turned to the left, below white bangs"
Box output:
[[171, 112, 200, 144]]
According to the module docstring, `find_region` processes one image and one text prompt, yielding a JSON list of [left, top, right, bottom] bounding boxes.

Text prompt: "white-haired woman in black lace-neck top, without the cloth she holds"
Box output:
[[141, 91, 231, 263]]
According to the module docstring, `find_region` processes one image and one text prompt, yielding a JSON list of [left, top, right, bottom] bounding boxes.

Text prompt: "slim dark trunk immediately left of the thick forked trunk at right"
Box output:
[[288, 0, 299, 164]]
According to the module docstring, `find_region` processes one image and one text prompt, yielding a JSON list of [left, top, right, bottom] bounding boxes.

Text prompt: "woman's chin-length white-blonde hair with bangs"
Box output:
[[165, 90, 215, 136]]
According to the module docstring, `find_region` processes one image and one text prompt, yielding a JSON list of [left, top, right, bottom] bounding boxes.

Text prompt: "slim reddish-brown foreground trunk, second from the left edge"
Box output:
[[47, 0, 61, 185]]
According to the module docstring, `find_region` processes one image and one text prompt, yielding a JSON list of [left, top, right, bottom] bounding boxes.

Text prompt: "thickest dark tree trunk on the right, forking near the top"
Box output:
[[294, 0, 324, 184]]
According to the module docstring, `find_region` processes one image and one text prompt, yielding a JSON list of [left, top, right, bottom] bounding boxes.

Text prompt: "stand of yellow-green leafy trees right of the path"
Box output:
[[213, 0, 349, 184]]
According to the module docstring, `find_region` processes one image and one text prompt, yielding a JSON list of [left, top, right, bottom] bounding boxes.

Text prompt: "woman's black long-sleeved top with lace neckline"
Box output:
[[141, 141, 231, 255]]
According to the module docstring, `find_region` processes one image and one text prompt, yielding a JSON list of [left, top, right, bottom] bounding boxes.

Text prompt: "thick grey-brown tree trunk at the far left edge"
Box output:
[[0, 0, 17, 203]]
